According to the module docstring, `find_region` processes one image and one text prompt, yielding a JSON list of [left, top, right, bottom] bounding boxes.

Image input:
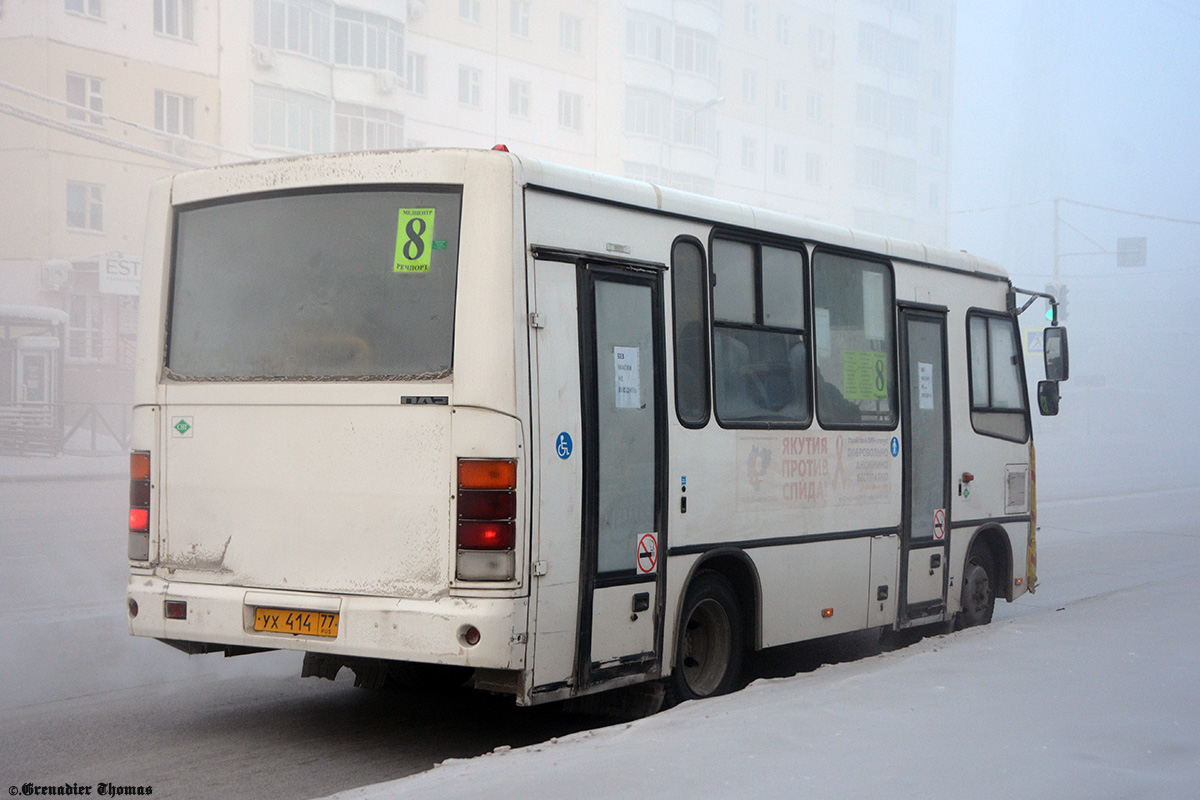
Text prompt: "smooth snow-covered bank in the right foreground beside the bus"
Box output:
[[324, 489, 1200, 800]]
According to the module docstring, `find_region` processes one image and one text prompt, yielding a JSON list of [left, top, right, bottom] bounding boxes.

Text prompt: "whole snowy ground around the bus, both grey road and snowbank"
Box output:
[[0, 470, 1200, 800]]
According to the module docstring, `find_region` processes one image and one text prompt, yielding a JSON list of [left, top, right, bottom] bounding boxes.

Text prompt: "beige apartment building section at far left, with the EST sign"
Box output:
[[0, 0, 220, 428]]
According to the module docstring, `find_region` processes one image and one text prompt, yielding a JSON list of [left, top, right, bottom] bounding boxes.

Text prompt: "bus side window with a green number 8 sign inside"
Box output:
[[812, 251, 896, 428]]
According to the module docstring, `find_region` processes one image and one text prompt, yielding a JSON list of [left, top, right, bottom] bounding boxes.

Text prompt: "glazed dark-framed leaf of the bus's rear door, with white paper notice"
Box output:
[[577, 265, 666, 686]]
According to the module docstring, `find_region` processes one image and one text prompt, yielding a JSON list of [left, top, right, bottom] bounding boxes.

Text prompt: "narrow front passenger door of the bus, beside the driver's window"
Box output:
[[899, 305, 950, 627]]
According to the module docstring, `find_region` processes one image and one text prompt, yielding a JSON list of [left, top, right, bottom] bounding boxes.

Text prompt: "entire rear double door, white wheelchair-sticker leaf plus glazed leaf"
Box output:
[[533, 260, 666, 691]]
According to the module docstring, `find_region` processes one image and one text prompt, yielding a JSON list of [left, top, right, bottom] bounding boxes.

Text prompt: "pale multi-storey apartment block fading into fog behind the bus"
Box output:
[[0, 0, 954, 450]]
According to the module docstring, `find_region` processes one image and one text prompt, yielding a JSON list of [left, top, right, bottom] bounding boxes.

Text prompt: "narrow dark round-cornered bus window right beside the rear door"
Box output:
[[671, 237, 709, 428]]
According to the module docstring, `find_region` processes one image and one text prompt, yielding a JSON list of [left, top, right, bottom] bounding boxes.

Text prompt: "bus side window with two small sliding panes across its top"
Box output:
[[713, 239, 811, 427]]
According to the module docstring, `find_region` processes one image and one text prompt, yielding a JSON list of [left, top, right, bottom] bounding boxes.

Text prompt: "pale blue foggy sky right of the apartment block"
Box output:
[[950, 0, 1200, 495]]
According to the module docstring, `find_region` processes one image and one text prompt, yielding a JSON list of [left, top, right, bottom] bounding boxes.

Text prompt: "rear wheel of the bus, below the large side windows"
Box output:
[[668, 571, 743, 703]]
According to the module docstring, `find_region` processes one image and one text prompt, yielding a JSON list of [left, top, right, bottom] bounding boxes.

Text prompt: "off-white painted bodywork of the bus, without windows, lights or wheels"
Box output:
[[130, 151, 1030, 703]]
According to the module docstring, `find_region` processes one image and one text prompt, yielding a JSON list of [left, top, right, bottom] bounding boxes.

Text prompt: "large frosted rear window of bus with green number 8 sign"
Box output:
[[167, 187, 462, 380]]
